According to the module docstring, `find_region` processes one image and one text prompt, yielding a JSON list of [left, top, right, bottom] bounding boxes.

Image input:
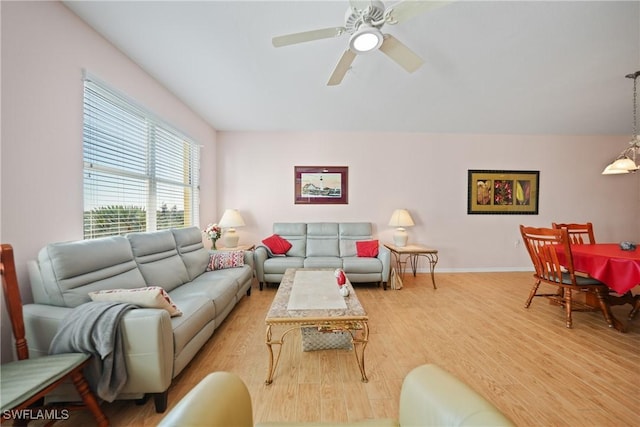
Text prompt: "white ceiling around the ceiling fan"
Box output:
[[65, 0, 640, 134]]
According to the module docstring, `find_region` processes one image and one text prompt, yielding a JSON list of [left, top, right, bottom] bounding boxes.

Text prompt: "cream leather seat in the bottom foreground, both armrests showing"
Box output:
[[158, 365, 515, 427]]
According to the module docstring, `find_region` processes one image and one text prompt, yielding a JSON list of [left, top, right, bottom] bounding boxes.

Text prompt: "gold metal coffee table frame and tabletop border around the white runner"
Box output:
[[265, 269, 369, 385]]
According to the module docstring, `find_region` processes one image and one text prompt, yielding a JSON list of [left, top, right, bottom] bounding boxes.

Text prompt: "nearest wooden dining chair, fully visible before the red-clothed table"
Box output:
[[520, 225, 613, 328]]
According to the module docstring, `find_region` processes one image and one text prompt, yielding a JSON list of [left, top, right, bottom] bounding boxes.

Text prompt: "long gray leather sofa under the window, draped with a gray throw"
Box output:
[[24, 227, 253, 412]]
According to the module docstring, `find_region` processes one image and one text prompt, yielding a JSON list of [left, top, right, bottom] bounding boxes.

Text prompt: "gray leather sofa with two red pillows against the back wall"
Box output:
[[254, 222, 391, 289]]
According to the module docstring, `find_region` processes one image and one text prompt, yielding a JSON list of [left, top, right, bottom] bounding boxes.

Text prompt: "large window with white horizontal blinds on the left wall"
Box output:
[[83, 74, 200, 239]]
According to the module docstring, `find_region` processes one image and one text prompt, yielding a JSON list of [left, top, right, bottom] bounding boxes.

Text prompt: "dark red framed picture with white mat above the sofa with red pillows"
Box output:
[[294, 166, 349, 205]]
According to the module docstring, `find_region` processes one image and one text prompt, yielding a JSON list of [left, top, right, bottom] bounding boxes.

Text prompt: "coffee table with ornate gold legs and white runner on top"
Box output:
[[265, 268, 369, 384]]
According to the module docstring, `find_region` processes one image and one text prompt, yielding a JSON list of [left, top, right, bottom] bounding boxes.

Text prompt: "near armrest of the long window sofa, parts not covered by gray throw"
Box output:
[[23, 304, 173, 393]]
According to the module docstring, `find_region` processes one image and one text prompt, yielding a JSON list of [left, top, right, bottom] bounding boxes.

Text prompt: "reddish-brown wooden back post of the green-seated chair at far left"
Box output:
[[0, 243, 29, 360]]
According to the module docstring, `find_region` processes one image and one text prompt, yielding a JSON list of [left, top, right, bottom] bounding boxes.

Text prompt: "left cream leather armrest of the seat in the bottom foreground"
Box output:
[[158, 372, 253, 427]]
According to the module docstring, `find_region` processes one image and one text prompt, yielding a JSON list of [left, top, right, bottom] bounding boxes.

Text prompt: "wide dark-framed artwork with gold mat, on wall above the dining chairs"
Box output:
[[467, 169, 540, 215]]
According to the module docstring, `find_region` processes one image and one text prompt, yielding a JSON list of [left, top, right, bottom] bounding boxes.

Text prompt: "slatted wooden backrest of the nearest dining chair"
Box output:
[[520, 225, 575, 285]]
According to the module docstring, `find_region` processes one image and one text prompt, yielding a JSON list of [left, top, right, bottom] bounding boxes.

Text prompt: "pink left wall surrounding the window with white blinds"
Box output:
[[0, 1, 216, 360]]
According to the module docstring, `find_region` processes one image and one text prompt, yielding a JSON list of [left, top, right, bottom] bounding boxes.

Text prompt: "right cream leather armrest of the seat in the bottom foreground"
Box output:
[[400, 365, 514, 427]]
